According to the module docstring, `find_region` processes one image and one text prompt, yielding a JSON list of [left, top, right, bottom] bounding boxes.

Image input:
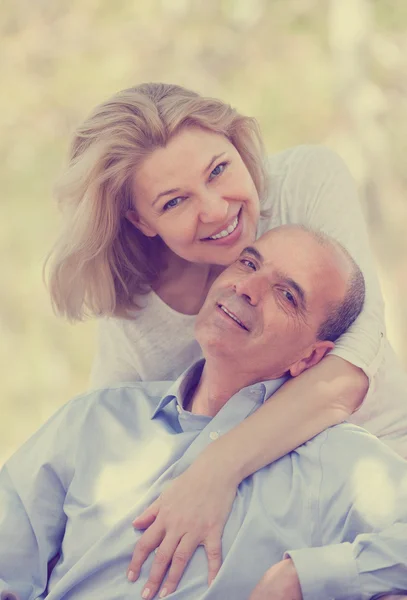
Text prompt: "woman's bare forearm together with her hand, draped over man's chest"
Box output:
[[128, 356, 368, 599]]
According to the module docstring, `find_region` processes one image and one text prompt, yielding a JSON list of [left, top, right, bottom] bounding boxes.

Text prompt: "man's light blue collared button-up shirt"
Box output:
[[0, 363, 407, 600]]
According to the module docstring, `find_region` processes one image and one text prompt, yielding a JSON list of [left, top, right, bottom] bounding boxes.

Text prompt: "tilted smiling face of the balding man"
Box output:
[[196, 227, 349, 381]]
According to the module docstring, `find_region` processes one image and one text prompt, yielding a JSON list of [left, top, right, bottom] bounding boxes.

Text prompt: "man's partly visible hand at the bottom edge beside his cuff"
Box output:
[[249, 558, 302, 600]]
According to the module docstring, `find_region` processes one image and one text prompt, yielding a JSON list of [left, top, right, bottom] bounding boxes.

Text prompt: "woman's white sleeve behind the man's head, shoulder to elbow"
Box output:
[[285, 146, 385, 384]]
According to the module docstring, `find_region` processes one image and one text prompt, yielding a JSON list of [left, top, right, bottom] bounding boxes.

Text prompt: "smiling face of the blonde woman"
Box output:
[[127, 127, 260, 265]]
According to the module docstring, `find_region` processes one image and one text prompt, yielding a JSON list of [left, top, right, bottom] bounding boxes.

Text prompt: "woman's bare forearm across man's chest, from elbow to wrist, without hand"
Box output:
[[201, 355, 368, 483]]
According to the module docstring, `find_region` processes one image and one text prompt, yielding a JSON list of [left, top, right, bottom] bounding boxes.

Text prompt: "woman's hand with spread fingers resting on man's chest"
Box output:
[[127, 458, 239, 599]]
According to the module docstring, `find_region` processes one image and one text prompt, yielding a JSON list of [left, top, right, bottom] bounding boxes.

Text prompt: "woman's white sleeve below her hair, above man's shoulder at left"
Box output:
[[89, 318, 141, 389]]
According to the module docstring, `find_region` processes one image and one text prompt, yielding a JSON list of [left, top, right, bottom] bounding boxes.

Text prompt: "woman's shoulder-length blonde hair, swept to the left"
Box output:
[[46, 83, 266, 320]]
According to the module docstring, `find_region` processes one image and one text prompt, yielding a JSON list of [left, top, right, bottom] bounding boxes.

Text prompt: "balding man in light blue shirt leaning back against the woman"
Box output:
[[0, 227, 407, 600]]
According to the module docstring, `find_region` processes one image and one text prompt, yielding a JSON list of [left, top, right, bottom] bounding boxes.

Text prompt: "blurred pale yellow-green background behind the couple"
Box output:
[[0, 0, 407, 464]]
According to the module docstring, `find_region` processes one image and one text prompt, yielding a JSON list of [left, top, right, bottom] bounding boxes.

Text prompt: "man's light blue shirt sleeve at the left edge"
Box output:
[[0, 398, 82, 600]]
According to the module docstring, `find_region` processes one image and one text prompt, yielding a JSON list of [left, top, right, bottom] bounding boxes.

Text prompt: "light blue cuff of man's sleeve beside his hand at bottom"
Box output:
[[284, 542, 362, 600]]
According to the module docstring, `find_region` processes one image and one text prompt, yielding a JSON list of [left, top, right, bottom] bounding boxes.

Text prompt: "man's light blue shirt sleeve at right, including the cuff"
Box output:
[[287, 426, 407, 600]]
